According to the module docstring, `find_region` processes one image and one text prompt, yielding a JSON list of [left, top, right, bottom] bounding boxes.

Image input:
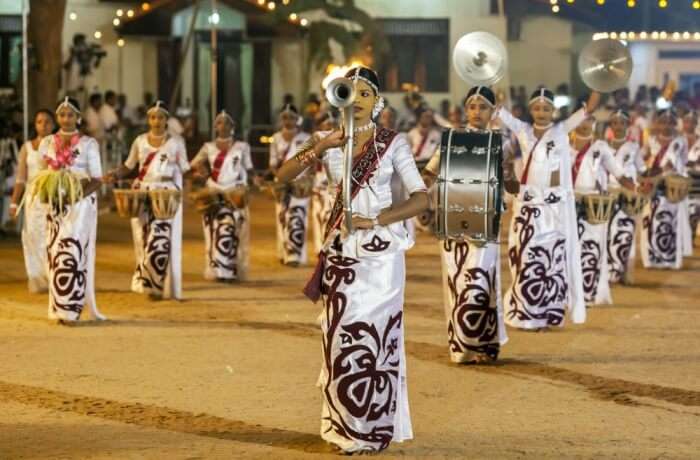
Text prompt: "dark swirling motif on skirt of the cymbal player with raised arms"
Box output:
[[508, 206, 568, 326]]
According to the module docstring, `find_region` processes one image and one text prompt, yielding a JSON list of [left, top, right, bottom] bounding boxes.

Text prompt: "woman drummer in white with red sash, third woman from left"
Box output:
[[110, 101, 190, 299]]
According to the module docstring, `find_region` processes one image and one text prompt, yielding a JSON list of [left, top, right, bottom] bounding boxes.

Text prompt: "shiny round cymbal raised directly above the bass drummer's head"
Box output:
[[452, 32, 508, 86]]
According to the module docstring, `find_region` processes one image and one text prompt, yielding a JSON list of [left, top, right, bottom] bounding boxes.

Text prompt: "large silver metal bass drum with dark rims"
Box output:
[[435, 129, 503, 245]]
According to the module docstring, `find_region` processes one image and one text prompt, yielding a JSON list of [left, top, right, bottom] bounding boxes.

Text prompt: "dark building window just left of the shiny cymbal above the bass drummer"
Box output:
[[377, 19, 450, 93]]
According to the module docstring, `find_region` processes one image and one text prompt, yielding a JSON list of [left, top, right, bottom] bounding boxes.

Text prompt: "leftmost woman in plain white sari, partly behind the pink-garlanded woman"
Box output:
[[10, 109, 56, 293]]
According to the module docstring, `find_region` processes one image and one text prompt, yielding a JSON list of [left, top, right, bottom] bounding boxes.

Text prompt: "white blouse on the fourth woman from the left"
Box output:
[[190, 141, 253, 189]]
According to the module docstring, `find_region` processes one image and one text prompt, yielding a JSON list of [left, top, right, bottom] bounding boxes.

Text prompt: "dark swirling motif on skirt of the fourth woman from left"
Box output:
[[204, 206, 243, 277]]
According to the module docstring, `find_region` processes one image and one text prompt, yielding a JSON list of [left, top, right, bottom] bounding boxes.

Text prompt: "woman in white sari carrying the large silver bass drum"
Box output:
[[424, 86, 517, 363]]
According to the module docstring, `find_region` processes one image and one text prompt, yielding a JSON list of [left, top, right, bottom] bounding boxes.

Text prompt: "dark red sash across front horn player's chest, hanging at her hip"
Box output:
[[303, 128, 397, 303]]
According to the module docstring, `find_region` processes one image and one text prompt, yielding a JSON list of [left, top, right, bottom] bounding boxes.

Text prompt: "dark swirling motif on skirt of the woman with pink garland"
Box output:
[[47, 209, 89, 319]]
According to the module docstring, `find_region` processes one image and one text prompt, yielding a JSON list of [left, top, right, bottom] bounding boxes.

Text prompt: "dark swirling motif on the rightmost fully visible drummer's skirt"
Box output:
[[643, 197, 678, 264]]
